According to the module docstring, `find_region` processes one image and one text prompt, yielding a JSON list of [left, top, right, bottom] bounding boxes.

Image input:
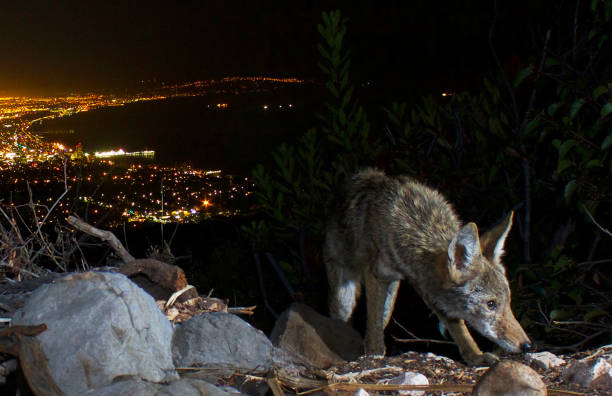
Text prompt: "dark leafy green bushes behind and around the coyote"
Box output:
[[243, 0, 612, 351]]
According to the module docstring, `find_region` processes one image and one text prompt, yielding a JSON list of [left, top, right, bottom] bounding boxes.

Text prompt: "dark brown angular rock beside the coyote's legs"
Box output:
[[270, 303, 363, 369]]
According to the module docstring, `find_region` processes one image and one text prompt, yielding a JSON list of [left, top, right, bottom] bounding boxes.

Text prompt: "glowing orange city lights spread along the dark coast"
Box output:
[[0, 77, 280, 226]]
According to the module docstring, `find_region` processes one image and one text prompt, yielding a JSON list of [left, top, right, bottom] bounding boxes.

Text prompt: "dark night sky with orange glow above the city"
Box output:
[[0, 0, 550, 95]]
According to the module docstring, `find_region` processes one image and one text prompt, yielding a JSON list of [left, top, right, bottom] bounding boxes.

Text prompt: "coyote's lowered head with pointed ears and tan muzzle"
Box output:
[[447, 212, 531, 352]]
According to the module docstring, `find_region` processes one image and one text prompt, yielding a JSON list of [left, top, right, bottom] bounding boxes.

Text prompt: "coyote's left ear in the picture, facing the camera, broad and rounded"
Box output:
[[448, 223, 482, 284]]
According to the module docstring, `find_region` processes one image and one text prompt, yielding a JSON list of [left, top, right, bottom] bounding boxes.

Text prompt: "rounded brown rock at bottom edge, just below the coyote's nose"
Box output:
[[472, 360, 547, 396]]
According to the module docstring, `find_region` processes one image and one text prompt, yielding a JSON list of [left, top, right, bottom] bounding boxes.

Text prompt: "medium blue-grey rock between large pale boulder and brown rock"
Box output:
[[172, 312, 279, 394]]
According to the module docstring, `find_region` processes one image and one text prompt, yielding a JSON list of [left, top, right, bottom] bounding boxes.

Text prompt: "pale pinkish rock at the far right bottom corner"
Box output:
[[563, 345, 612, 391]]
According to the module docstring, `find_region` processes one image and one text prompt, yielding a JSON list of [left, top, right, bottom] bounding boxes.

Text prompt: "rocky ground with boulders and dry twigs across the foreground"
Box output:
[[0, 260, 612, 396]]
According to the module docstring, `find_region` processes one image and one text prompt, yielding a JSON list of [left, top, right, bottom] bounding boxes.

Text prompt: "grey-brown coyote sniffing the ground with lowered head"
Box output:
[[323, 168, 531, 365]]
